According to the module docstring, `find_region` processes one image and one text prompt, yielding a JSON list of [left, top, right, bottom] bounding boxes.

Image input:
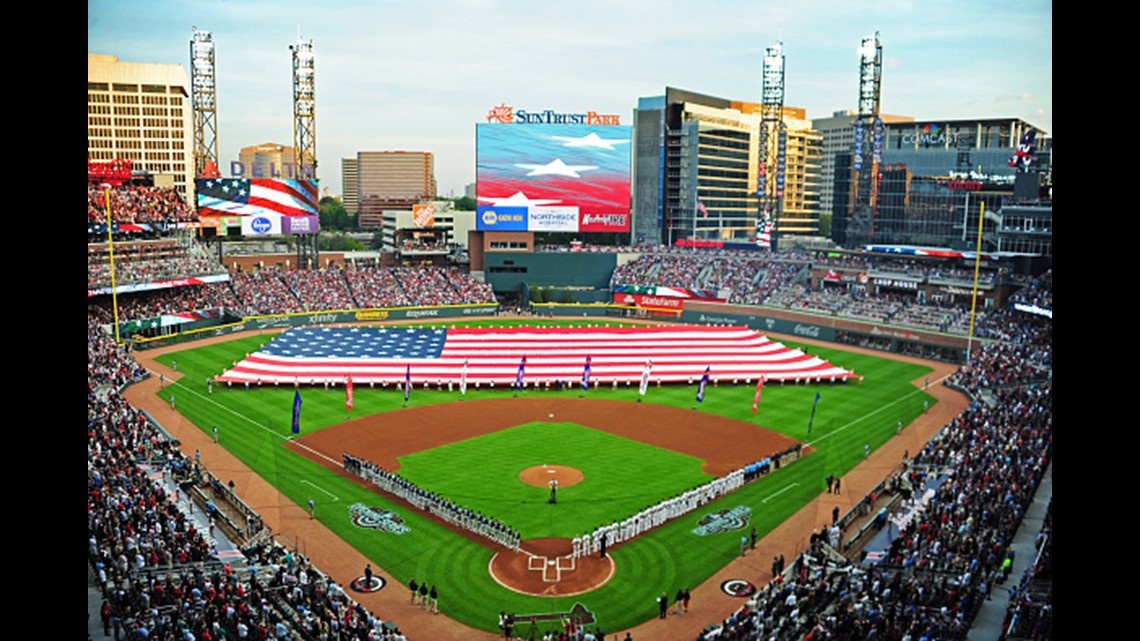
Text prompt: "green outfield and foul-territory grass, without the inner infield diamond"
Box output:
[[158, 322, 935, 632]]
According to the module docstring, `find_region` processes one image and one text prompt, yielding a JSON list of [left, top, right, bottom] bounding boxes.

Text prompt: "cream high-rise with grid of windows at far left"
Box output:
[[87, 54, 195, 200]]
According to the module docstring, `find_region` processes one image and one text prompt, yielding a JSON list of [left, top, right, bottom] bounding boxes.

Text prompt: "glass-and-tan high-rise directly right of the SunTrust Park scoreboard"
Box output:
[[630, 87, 822, 244]]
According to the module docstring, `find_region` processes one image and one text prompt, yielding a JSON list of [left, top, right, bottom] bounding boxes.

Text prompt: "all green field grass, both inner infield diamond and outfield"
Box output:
[[158, 321, 935, 632]]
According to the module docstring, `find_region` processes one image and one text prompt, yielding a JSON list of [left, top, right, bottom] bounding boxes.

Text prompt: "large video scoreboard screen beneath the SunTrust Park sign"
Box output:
[[475, 117, 633, 232]]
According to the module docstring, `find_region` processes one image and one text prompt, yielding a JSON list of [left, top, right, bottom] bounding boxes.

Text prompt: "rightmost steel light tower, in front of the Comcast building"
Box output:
[[848, 32, 884, 242]]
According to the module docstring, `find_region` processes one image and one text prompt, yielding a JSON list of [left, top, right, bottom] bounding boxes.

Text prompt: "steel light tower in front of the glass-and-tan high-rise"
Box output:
[[756, 42, 788, 251]]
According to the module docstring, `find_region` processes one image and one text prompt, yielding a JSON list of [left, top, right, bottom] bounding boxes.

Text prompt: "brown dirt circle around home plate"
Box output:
[[488, 533, 614, 597]]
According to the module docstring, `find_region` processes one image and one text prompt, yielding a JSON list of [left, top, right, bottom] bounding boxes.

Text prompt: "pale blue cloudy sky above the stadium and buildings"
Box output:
[[87, 0, 1053, 197]]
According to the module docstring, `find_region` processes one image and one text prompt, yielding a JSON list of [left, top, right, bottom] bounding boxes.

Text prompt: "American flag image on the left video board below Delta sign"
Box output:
[[197, 178, 320, 217]]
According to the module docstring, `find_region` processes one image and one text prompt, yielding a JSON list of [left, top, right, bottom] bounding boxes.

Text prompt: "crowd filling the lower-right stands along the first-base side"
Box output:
[[684, 307, 1052, 641]]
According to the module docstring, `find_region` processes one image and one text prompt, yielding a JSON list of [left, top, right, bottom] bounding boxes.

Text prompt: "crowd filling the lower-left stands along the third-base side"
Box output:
[[87, 313, 405, 641]]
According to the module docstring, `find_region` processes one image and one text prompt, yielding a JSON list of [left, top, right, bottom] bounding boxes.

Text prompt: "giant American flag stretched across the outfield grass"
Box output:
[[219, 325, 854, 386]]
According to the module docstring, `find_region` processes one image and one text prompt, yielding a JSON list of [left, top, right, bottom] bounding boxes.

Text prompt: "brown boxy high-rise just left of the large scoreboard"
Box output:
[[357, 152, 437, 229]]
